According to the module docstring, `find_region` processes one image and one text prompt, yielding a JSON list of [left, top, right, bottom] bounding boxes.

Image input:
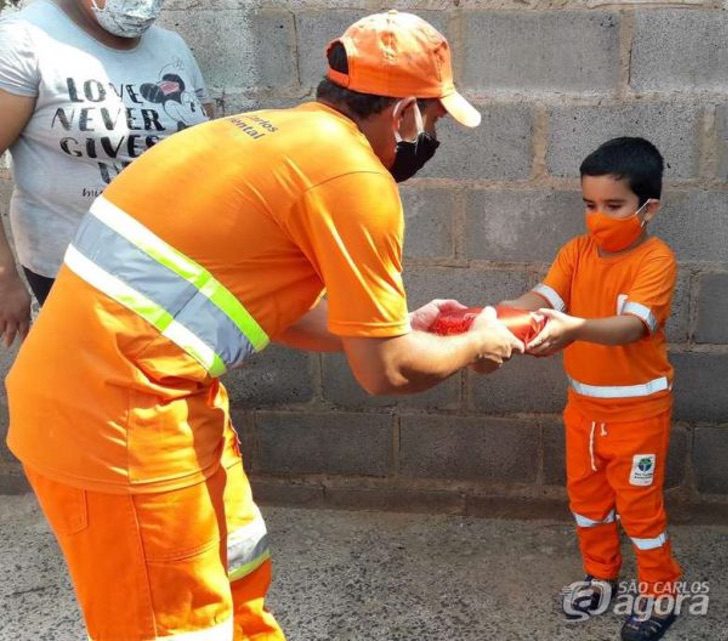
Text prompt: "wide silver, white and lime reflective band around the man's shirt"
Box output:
[[65, 197, 269, 376]]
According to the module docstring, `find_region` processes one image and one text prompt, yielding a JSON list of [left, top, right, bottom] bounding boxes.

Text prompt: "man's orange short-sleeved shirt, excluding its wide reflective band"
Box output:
[[7, 103, 409, 492]]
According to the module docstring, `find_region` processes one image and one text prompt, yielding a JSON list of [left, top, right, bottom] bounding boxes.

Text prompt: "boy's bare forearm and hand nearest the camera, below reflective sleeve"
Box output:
[[526, 308, 649, 356]]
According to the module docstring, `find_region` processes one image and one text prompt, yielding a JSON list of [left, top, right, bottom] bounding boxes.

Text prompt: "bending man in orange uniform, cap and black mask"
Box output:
[[2, 12, 523, 641]]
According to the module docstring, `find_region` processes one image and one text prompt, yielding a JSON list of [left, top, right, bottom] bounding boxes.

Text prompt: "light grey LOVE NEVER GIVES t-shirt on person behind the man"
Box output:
[[0, 0, 209, 277]]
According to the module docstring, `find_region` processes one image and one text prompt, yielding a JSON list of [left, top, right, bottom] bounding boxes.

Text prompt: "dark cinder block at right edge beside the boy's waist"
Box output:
[[670, 352, 728, 423]]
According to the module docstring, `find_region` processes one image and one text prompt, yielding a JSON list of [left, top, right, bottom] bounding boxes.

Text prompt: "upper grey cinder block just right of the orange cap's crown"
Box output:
[[463, 9, 619, 94]]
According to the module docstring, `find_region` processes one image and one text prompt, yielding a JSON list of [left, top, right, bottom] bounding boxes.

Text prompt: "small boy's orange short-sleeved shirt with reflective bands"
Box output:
[[536, 235, 677, 421]]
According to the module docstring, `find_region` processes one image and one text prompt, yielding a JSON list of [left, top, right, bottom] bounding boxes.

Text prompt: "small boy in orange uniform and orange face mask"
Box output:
[[500, 138, 680, 641]]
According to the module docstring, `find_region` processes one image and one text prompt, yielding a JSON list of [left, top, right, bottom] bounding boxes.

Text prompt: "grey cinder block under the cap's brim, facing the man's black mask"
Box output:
[[417, 104, 533, 180]]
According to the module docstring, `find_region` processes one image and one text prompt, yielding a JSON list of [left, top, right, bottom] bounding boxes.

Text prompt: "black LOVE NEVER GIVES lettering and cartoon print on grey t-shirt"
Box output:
[[51, 58, 205, 189]]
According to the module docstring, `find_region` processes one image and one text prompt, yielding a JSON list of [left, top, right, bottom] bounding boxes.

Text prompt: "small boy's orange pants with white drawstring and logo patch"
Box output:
[[564, 403, 681, 595]]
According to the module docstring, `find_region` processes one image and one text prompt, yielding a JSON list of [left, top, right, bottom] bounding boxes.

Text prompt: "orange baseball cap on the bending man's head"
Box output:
[[326, 9, 481, 127]]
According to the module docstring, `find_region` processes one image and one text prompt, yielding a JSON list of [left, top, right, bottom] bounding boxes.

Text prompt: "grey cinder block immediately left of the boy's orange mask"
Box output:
[[465, 190, 584, 263]]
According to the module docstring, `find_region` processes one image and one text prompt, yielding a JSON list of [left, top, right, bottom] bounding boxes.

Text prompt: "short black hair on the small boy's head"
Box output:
[[579, 136, 665, 207]]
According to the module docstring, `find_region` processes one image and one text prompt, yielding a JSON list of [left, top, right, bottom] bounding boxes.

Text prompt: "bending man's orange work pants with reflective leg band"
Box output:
[[26, 463, 284, 641]]
